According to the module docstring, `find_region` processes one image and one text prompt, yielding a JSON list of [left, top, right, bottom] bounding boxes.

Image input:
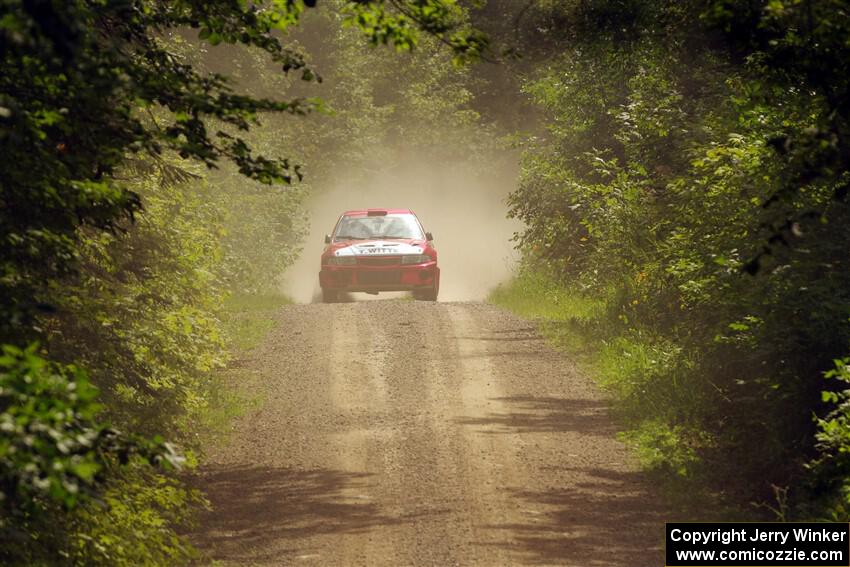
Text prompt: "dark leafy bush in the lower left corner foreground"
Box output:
[[0, 344, 182, 565]]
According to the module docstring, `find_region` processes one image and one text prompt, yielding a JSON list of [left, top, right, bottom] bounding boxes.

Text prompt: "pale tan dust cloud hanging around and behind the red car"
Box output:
[[283, 154, 520, 303]]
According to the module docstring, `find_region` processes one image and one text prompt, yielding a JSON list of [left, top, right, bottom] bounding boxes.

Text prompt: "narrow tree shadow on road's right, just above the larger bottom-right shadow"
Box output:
[[455, 396, 617, 437]]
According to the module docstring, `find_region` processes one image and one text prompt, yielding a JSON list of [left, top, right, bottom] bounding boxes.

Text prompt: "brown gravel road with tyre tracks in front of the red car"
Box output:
[[195, 300, 664, 567]]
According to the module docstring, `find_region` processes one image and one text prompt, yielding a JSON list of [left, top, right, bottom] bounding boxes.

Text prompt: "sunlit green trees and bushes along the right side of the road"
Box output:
[[494, 0, 850, 519]]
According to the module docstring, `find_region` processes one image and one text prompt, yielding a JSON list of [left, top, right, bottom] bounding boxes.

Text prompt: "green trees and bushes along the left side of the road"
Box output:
[[0, 0, 486, 565]]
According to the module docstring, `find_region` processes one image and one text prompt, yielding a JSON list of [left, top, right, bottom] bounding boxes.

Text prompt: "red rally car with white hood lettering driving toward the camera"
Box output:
[[319, 209, 440, 303]]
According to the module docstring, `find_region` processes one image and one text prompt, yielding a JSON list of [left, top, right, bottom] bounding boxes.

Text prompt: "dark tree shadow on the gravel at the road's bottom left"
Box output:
[[191, 466, 415, 564]]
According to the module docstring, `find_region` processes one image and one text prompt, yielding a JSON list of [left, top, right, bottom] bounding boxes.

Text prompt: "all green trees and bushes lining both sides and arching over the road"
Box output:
[[6, 0, 850, 565]]
